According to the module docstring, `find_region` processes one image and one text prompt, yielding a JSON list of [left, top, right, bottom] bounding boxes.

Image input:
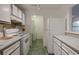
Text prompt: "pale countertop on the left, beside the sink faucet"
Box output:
[[0, 33, 27, 51]]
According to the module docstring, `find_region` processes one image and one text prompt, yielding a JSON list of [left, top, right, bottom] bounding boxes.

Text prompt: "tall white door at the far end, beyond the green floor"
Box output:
[[32, 15, 43, 40]]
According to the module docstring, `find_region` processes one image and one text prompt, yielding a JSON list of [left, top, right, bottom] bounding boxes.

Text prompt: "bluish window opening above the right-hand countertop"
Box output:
[[72, 4, 79, 32]]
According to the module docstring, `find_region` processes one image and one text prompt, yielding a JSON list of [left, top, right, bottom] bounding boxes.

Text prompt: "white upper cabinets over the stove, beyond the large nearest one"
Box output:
[[11, 5, 25, 25]]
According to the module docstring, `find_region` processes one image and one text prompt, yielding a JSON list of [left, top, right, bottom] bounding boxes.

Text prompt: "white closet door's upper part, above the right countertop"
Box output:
[[50, 18, 65, 35]]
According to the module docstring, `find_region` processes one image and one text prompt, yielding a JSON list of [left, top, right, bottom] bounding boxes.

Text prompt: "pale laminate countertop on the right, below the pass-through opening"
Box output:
[[54, 35, 79, 54]]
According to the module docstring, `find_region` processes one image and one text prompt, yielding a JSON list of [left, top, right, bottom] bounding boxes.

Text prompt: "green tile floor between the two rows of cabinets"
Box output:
[[28, 39, 48, 55]]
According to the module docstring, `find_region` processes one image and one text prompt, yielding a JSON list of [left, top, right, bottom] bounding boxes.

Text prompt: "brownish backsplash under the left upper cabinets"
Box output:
[[0, 23, 29, 34]]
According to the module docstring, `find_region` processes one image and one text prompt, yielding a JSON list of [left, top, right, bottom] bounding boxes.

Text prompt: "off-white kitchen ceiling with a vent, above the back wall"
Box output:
[[18, 4, 74, 10]]
